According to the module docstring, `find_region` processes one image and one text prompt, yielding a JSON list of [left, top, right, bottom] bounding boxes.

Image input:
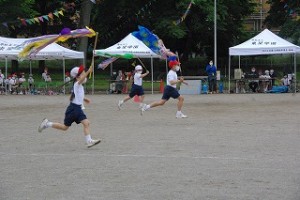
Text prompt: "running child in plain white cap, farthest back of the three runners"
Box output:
[[118, 65, 149, 110]]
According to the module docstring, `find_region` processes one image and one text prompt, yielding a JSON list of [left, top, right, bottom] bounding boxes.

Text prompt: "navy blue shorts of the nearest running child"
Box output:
[[64, 103, 87, 126]]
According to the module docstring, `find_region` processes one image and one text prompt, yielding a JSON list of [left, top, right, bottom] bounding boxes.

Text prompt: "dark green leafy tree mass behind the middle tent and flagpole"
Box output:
[[91, 0, 255, 63]]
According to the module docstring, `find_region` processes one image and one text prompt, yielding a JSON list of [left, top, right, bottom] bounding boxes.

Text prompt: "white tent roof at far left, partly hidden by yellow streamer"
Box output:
[[0, 37, 84, 60]]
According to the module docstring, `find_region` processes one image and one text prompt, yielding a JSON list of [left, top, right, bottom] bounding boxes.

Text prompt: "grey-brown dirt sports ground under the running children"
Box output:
[[0, 94, 300, 200]]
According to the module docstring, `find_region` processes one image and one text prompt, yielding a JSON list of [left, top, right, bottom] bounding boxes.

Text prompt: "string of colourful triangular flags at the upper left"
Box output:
[[2, 10, 64, 29]]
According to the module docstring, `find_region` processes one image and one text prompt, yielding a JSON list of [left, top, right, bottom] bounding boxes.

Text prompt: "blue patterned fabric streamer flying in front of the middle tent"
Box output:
[[132, 26, 176, 59]]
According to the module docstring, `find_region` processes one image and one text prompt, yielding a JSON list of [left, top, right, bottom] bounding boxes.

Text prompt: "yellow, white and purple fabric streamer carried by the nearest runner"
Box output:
[[16, 27, 96, 59]]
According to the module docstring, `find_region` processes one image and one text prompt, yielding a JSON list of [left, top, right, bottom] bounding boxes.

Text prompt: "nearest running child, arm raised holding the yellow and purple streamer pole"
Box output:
[[38, 65, 101, 148]]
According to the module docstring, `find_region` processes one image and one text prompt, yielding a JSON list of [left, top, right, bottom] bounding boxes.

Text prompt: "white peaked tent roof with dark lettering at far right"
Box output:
[[229, 29, 300, 55]]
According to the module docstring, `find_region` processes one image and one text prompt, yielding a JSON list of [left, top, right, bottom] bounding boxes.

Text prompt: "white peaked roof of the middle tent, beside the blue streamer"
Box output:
[[94, 33, 160, 58]]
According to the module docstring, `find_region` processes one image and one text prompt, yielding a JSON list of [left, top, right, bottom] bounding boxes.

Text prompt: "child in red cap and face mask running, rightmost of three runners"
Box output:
[[141, 60, 187, 118]]
